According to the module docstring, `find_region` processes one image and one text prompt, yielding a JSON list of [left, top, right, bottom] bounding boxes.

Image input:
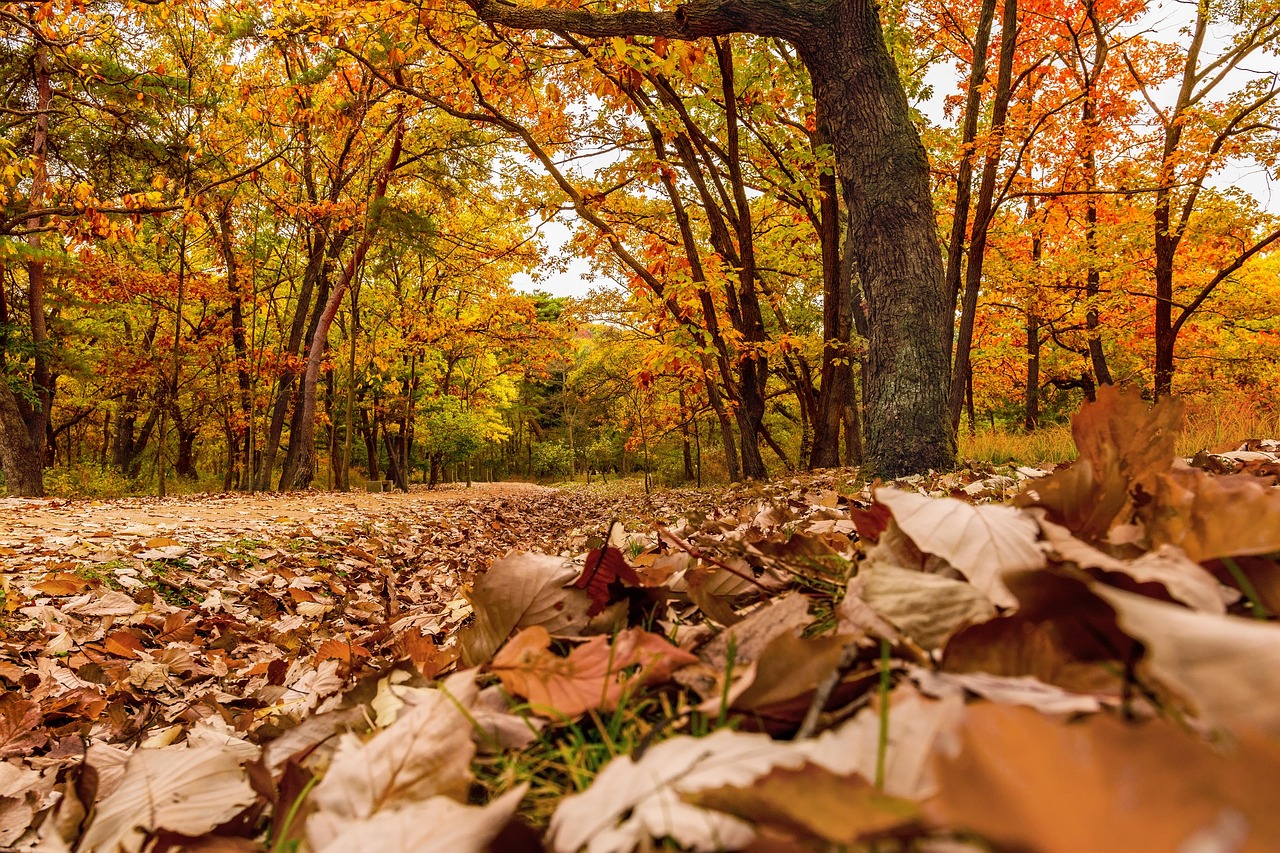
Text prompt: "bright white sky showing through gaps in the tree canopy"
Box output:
[[513, 0, 1280, 297]]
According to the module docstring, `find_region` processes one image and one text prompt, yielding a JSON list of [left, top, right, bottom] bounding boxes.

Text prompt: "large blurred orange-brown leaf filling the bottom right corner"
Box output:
[[927, 703, 1280, 853]]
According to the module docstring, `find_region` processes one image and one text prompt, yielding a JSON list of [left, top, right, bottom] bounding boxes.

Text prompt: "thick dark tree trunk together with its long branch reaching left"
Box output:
[[458, 0, 955, 476]]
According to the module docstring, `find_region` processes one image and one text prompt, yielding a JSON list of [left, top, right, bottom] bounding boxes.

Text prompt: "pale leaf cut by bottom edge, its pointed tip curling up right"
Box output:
[[319, 783, 529, 853]]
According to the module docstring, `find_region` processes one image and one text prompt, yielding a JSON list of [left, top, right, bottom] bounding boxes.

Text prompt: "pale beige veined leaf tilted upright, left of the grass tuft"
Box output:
[[307, 690, 475, 849]]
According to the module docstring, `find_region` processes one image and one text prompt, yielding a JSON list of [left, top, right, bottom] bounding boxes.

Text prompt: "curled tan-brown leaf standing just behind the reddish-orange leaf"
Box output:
[[458, 552, 591, 666]]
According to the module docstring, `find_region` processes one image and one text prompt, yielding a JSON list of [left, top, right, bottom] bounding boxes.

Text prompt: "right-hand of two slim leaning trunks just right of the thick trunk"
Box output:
[[950, 0, 1018, 432]]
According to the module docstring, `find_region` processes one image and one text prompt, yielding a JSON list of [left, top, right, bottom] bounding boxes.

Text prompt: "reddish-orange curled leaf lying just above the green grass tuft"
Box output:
[[488, 626, 698, 717]]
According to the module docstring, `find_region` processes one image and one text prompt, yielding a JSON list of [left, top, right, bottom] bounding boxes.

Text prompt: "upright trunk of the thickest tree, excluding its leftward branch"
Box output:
[[797, 0, 955, 476]]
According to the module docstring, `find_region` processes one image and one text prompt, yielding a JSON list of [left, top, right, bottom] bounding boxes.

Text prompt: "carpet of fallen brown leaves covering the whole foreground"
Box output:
[[0, 389, 1280, 853]]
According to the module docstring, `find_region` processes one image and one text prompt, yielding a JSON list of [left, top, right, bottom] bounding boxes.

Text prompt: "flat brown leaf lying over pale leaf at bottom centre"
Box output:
[[685, 763, 923, 845]]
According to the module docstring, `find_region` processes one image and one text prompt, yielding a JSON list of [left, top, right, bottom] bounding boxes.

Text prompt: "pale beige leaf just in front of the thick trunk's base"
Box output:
[[876, 488, 1044, 607]]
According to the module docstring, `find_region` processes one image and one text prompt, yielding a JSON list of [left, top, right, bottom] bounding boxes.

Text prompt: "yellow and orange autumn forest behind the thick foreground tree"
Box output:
[[0, 0, 1280, 494]]
